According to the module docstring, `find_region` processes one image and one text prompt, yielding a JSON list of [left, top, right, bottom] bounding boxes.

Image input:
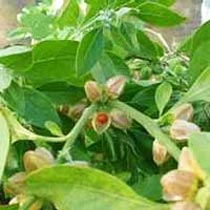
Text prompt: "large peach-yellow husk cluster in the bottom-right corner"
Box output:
[[161, 147, 206, 210]]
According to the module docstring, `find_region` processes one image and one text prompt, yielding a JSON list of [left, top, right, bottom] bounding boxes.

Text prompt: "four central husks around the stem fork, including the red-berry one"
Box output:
[[85, 76, 131, 134]]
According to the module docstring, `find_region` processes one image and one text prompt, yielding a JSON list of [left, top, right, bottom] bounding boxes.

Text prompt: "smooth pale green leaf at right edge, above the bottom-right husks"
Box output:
[[188, 132, 210, 174]]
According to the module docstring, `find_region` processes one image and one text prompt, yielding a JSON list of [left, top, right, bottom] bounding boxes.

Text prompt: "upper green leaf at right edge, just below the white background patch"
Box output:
[[179, 21, 210, 57]]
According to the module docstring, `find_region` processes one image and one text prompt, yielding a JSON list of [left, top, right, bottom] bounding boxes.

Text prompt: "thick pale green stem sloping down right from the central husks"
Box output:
[[111, 101, 180, 161]]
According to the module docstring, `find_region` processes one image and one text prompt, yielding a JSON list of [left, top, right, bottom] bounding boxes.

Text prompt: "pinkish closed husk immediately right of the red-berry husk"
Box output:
[[110, 109, 132, 130]]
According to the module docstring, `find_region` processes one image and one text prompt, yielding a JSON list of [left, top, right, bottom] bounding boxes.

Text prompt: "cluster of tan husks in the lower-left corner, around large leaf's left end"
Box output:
[[5, 147, 54, 210]]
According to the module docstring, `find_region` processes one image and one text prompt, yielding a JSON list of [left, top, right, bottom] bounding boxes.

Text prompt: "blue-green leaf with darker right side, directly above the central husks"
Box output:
[[91, 53, 130, 84]]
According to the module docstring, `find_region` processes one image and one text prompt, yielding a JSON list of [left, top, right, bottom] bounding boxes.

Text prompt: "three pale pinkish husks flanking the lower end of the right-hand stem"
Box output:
[[153, 104, 200, 165]]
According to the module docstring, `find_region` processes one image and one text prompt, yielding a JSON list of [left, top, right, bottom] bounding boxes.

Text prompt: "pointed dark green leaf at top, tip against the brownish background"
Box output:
[[137, 2, 185, 27]]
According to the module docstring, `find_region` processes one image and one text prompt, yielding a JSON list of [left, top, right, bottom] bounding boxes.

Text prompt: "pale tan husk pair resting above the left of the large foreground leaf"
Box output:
[[23, 147, 54, 172]]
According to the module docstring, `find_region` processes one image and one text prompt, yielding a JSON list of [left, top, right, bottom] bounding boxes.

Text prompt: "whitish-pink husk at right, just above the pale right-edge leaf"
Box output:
[[170, 120, 200, 140]]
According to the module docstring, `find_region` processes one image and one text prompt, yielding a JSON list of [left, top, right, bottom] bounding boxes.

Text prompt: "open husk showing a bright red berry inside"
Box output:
[[92, 112, 111, 134]]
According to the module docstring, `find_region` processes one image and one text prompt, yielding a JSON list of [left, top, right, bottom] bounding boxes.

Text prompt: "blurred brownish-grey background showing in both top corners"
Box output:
[[0, 0, 210, 47]]
